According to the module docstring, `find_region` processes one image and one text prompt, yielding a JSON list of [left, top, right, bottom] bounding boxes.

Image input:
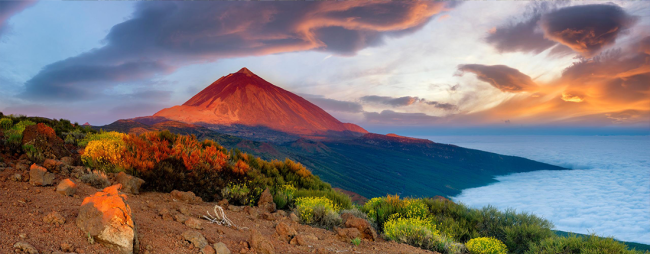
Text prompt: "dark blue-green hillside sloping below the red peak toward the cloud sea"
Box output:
[[95, 120, 563, 197]]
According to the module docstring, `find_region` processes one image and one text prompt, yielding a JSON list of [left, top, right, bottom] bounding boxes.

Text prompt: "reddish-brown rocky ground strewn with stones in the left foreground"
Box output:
[[0, 157, 431, 253]]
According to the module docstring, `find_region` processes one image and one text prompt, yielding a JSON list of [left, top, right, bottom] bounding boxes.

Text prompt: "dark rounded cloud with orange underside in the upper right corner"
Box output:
[[540, 4, 636, 57]]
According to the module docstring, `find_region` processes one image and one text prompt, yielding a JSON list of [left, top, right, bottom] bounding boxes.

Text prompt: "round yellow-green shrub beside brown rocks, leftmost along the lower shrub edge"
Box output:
[[295, 197, 341, 225]]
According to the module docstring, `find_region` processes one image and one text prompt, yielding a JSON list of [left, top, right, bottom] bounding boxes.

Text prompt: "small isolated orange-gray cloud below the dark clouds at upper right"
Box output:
[[456, 64, 537, 93]]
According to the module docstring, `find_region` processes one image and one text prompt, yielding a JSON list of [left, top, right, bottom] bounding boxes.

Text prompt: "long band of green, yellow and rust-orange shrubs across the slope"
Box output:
[[0, 113, 649, 254]]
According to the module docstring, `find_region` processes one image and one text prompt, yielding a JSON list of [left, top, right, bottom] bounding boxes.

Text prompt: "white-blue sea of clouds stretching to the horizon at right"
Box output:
[[416, 136, 650, 244]]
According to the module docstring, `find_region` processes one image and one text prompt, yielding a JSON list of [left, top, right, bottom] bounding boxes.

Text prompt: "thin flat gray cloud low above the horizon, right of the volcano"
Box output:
[[363, 110, 441, 126]]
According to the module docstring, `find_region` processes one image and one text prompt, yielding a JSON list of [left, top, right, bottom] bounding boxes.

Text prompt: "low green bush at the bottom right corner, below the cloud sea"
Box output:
[[526, 235, 649, 254]]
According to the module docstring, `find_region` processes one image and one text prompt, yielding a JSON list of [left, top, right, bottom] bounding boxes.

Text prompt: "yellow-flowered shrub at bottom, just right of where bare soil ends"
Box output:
[[384, 214, 439, 249]]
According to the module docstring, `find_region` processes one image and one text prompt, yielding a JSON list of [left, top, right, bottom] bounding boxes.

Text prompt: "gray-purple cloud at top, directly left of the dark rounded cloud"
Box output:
[[486, 1, 566, 53]]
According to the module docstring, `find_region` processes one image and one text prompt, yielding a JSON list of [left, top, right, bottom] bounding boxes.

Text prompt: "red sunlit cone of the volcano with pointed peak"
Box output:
[[153, 68, 367, 136]]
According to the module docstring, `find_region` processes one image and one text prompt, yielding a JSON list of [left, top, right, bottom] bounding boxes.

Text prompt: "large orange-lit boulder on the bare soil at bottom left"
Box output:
[[77, 184, 138, 253]]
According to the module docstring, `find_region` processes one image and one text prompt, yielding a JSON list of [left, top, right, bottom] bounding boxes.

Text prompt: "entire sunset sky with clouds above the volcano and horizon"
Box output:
[[0, 0, 650, 135]]
